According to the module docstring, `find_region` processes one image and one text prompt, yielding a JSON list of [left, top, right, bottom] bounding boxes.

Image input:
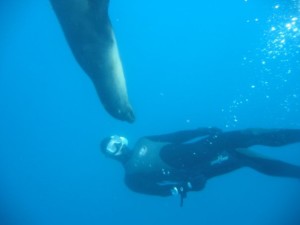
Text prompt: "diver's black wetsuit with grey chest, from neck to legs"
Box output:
[[123, 128, 300, 203]]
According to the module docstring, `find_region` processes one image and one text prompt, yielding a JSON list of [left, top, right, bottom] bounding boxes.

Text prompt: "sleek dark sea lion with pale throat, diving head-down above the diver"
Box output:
[[50, 0, 135, 123]]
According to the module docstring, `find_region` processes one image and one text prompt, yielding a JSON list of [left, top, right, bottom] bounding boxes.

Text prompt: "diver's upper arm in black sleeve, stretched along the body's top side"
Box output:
[[146, 127, 221, 143]]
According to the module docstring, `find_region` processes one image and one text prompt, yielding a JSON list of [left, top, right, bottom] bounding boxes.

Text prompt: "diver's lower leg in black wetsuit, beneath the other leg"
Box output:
[[235, 149, 300, 179]]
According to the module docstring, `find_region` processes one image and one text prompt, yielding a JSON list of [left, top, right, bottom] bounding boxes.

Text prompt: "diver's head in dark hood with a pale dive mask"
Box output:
[[101, 135, 130, 161]]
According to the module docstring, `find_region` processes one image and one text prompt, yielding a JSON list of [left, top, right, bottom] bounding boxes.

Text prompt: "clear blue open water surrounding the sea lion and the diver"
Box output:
[[0, 0, 300, 225]]
